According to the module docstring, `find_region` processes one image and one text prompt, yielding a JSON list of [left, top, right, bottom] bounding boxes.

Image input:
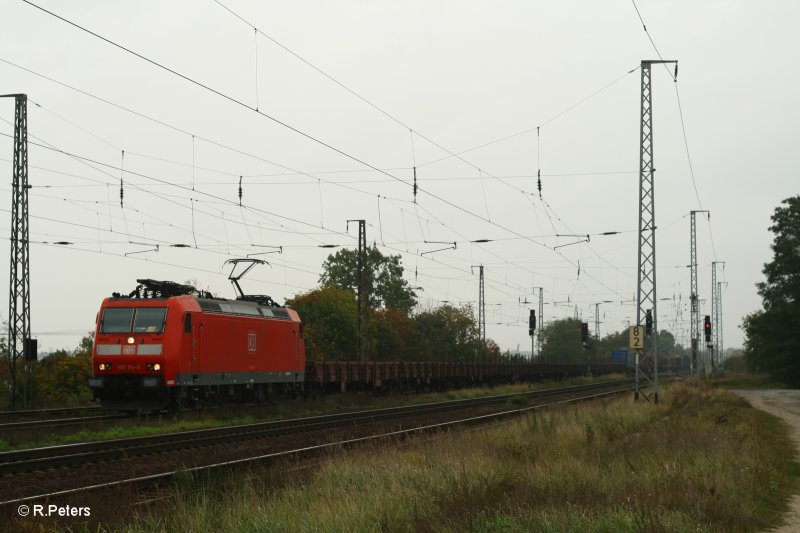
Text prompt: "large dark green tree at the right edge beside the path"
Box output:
[[742, 196, 800, 386]]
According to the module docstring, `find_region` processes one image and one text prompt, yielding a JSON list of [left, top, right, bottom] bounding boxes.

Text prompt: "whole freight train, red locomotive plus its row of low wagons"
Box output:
[[89, 278, 625, 411]]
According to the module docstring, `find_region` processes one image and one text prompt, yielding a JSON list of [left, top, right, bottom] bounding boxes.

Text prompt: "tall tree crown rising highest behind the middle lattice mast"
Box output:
[[319, 246, 417, 315]]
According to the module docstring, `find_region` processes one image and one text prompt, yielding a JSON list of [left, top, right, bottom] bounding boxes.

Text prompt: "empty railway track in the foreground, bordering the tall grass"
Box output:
[[0, 380, 644, 509]]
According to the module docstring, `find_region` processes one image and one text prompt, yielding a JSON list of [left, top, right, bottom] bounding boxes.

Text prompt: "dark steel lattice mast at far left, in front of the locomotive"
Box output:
[[0, 94, 31, 409]]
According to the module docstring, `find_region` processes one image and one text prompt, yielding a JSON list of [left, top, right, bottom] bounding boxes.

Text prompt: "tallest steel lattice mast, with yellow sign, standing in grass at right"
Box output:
[[636, 60, 678, 403]]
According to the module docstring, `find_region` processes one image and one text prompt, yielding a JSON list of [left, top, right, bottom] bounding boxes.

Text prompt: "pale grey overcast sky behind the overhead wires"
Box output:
[[0, 0, 800, 351]]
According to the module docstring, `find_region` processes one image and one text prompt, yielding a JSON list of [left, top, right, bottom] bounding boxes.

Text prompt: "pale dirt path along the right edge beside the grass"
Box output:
[[731, 390, 800, 533]]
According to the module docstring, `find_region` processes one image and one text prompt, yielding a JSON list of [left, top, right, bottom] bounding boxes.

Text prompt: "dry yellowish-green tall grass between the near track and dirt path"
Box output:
[[103, 382, 798, 532]]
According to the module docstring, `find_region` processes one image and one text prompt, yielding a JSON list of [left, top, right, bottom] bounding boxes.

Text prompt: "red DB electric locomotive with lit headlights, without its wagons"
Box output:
[[89, 264, 306, 410]]
